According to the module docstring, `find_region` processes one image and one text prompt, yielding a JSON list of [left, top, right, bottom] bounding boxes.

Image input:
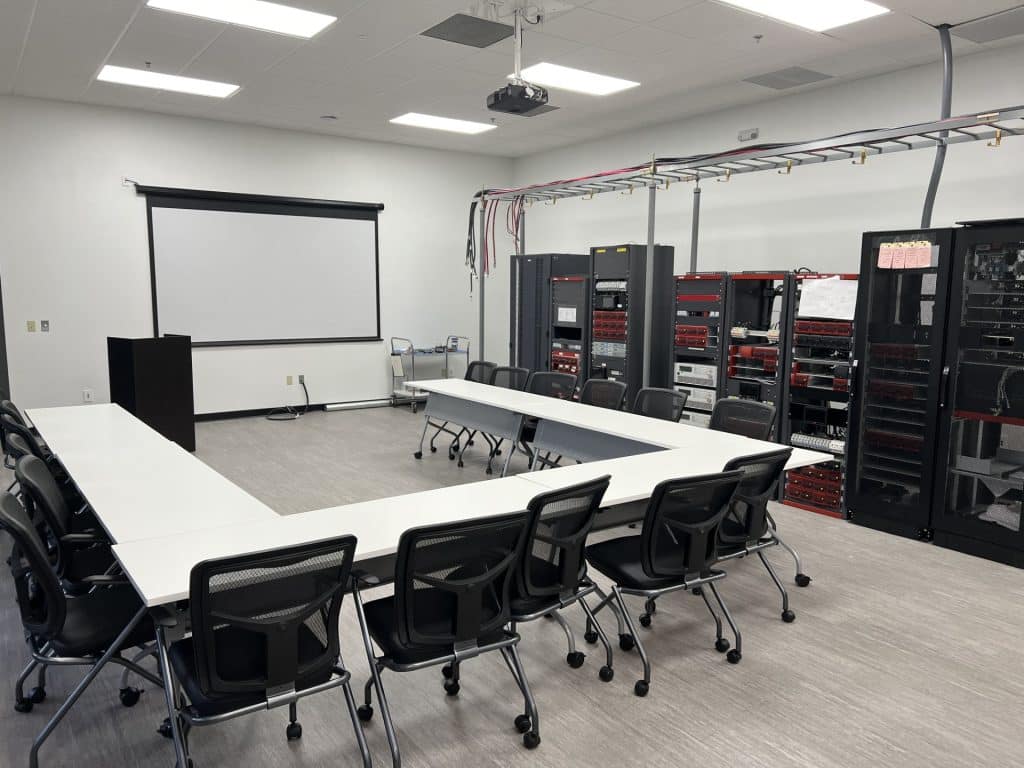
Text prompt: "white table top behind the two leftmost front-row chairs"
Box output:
[[114, 476, 544, 607]]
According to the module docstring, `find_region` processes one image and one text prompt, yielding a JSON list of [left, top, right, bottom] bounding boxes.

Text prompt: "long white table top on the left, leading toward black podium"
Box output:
[[29, 404, 278, 543]]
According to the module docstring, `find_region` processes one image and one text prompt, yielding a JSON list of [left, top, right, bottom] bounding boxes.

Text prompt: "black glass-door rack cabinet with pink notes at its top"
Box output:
[[846, 229, 953, 540]]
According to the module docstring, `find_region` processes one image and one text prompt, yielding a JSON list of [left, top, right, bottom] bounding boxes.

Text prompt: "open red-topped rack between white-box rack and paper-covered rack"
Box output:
[[723, 272, 796, 439]]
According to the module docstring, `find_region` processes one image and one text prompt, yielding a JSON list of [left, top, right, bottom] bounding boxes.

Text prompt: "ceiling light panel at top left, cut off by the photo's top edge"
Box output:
[[146, 0, 338, 39]]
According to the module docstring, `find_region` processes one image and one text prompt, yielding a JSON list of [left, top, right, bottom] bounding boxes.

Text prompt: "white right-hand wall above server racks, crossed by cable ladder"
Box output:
[[516, 40, 1024, 280]]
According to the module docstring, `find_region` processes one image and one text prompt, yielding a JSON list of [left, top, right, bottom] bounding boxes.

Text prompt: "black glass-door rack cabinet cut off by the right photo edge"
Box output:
[[934, 222, 1024, 566]]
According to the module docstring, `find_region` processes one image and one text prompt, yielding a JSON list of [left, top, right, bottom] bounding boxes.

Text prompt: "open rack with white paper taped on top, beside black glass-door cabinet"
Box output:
[[780, 272, 857, 518]]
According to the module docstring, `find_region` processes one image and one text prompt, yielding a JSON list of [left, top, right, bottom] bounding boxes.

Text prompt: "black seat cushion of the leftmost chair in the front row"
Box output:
[[168, 625, 336, 717]]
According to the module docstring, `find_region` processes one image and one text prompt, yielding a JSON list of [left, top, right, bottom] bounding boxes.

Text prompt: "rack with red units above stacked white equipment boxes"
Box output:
[[670, 272, 729, 427]]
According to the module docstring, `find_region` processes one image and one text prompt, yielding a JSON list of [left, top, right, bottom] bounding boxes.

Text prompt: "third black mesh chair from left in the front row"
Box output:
[[512, 475, 614, 688]]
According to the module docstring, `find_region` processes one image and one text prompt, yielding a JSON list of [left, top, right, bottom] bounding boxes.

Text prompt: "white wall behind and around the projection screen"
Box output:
[[0, 97, 512, 414]]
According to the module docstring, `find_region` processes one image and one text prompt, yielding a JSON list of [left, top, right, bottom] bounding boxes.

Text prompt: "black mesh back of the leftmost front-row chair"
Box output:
[[189, 536, 355, 696]]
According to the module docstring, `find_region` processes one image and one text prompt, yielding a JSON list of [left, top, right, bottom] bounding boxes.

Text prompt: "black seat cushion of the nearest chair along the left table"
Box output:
[[53, 585, 155, 656]]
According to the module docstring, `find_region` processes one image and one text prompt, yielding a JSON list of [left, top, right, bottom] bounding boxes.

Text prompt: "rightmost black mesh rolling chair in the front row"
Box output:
[[718, 447, 811, 606]]
